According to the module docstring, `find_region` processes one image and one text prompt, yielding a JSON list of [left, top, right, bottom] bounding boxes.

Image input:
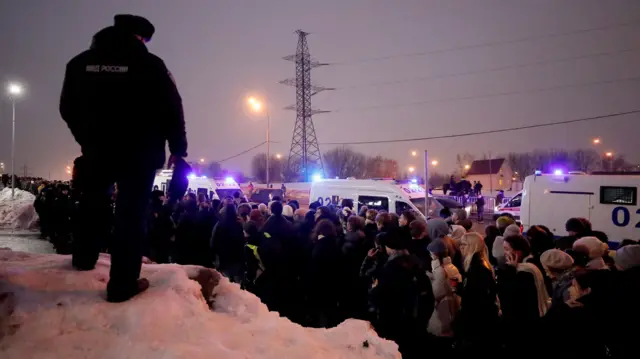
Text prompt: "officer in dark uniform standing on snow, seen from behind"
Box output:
[[60, 15, 187, 302]]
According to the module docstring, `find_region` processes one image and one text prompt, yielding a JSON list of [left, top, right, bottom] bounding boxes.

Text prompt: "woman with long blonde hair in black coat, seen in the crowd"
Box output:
[[454, 233, 498, 354]]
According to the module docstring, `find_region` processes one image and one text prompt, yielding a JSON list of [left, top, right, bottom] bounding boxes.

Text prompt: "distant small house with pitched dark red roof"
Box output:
[[465, 158, 521, 194]]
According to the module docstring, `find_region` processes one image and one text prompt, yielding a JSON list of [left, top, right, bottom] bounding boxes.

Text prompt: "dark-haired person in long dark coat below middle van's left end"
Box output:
[[305, 219, 344, 328]]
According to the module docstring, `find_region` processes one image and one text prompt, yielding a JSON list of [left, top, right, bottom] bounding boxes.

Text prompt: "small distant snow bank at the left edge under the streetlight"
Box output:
[[0, 188, 38, 229]]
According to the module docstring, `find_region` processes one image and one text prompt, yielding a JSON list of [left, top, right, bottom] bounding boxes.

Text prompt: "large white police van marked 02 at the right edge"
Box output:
[[520, 172, 640, 246]]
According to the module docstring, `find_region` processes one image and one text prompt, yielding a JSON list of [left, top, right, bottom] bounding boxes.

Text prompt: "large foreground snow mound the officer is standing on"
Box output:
[[0, 250, 400, 359]]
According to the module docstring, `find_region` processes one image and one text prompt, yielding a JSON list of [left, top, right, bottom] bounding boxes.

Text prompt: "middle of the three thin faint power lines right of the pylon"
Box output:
[[336, 48, 639, 90]]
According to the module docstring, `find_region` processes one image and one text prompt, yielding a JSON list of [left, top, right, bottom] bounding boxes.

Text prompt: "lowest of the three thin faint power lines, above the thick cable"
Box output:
[[333, 76, 640, 112]]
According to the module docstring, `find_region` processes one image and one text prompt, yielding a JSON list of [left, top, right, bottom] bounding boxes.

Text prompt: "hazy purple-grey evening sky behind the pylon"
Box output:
[[0, 0, 640, 178]]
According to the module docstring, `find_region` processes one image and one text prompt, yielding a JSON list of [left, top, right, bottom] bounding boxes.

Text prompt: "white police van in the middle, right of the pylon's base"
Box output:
[[309, 179, 461, 218]]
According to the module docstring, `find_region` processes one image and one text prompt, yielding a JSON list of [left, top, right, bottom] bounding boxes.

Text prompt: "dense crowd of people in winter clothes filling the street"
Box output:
[[31, 185, 640, 358]]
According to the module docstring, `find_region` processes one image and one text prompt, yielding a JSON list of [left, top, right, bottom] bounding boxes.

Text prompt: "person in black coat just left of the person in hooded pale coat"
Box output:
[[369, 233, 434, 358]]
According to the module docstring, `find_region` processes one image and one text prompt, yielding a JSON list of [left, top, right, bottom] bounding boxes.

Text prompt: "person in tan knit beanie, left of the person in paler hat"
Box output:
[[540, 249, 575, 308]]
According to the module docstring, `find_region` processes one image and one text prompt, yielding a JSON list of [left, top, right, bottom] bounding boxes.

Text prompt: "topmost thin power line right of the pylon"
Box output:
[[331, 19, 640, 65]]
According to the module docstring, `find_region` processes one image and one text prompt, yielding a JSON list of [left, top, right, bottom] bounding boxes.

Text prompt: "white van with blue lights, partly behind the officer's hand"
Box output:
[[153, 170, 243, 199]]
